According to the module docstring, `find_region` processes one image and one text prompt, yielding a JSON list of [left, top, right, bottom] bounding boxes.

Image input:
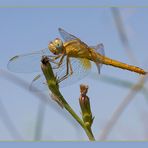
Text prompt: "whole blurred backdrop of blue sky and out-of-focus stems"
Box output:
[[0, 4, 148, 141]]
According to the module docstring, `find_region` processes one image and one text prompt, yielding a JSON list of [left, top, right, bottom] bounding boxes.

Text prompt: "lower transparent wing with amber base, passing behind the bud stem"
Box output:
[[30, 58, 91, 91]]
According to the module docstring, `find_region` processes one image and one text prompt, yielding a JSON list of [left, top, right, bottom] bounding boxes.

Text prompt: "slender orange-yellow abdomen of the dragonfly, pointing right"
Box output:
[[99, 57, 147, 75]]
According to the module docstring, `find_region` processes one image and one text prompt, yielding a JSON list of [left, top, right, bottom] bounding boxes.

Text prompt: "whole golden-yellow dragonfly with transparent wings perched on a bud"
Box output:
[[8, 28, 147, 90]]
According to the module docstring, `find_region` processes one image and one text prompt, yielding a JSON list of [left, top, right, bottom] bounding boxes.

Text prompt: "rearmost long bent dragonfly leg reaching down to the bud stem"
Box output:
[[58, 56, 73, 83]]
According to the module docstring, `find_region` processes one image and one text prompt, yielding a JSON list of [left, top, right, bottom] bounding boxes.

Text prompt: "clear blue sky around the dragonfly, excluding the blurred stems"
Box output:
[[0, 1, 148, 140]]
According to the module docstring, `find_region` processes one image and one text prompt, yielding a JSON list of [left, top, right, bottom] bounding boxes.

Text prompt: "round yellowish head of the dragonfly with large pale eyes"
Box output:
[[48, 38, 64, 55]]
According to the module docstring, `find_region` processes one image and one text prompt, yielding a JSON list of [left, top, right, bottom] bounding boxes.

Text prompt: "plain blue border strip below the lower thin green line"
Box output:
[[1, 142, 148, 148]]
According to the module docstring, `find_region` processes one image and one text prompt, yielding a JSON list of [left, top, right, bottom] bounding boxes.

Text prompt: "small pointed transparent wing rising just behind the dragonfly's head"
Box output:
[[58, 28, 79, 42]]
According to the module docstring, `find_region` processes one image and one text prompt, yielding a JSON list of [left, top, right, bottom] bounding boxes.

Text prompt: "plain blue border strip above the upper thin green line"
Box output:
[[1, 0, 148, 6]]
